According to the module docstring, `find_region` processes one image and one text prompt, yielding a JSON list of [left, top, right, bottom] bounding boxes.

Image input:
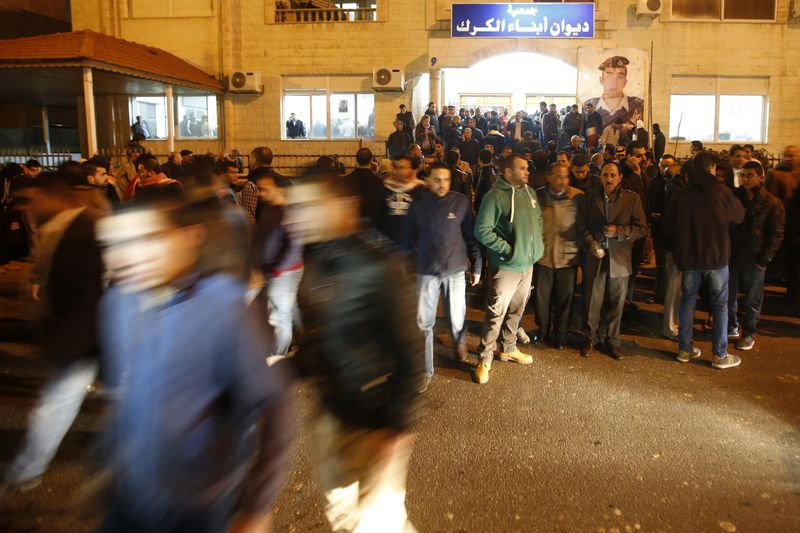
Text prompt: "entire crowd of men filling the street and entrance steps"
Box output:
[[0, 123, 800, 531]]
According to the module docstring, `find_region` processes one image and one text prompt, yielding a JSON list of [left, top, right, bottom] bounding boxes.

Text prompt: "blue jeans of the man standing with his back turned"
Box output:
[[678, 267, 728, 357]]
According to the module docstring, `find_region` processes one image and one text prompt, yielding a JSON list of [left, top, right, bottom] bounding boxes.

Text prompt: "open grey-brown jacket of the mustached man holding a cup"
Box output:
[[577, 187, 647, 278]]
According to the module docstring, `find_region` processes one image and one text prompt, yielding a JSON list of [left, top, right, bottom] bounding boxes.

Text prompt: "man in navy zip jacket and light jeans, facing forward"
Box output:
[[404, 160, 482, 390]]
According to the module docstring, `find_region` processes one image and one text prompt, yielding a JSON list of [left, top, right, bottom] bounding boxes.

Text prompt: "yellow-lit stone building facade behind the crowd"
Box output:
[[71, 0, 800, 161]]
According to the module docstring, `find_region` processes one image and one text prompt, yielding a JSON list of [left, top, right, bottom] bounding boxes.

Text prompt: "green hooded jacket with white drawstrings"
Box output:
[[475, 178, 544, 272]]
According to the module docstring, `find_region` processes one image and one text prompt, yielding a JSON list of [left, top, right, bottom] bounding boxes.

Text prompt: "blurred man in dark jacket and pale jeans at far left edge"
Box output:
[[0, 172, 103, 499]]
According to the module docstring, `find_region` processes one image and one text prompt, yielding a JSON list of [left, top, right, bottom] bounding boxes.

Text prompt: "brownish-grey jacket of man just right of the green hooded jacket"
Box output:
[[536, 186, 583, 268]]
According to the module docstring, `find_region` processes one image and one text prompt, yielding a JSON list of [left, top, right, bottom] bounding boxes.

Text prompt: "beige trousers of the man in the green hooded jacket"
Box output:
[[478, 267, 533, 363]]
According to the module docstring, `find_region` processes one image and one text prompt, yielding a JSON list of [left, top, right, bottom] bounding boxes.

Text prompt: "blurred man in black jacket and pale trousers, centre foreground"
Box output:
[[288, 177, 423, 531]]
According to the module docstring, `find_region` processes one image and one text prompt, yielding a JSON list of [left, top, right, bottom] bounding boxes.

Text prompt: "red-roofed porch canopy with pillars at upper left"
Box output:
[[0, 30, 224, 155]]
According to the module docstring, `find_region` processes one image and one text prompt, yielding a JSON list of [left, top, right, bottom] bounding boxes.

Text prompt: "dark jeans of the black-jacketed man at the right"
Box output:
[[728, 261, 766, 336]]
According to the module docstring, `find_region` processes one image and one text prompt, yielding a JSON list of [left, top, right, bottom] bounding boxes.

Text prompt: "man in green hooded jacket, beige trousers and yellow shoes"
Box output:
[[475, 154, 544, 383]]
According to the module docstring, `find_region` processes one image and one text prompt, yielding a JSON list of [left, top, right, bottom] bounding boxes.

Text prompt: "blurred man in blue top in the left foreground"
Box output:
[[98, 199, 291, 533]]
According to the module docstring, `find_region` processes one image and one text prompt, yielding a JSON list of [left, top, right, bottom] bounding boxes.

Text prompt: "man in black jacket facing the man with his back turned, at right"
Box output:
[[728, 161, 785, 350]]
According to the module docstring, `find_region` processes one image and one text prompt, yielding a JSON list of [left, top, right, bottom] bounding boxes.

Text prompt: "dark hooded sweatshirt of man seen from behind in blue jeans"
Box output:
[[662, 172, 744, 270]]
